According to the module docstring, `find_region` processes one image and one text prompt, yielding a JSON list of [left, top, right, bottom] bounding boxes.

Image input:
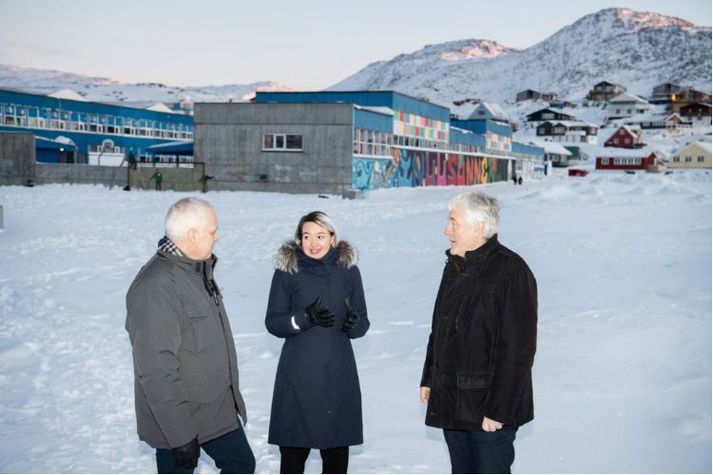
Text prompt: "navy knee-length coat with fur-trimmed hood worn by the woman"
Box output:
[[265, 241, 369, 449]]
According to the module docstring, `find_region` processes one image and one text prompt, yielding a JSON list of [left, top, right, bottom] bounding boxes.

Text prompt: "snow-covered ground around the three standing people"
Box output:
[[0, 170, 711, 473]]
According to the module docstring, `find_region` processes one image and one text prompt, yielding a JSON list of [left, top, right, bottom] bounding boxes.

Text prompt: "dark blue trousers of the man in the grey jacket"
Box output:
[[156, 428, 255, 473]]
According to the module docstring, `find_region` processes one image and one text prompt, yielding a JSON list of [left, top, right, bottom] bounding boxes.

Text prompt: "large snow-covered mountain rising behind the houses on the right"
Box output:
[[329, 8, 711, 106]]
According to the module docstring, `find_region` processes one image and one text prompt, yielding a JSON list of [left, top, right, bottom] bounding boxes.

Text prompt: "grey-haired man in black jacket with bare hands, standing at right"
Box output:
[[421, 192, 537, 473]]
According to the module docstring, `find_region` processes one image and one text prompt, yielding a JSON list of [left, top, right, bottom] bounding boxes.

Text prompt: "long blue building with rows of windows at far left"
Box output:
[[0, 89, 193, 165]]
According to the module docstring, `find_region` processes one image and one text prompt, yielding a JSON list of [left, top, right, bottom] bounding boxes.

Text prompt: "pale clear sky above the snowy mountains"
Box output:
[[0, 0, 711, 90]]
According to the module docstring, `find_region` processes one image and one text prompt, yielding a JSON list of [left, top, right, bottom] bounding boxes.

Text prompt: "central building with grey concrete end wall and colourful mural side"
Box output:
[[194, 91, 528, 196]]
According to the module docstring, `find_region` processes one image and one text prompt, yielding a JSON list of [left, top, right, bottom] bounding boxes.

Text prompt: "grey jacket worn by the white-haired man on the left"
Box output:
[[126, 251, 247, 448]]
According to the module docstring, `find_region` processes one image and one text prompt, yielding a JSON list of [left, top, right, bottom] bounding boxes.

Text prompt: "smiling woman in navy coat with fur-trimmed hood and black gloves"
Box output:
[[265, 211, 369, 473]]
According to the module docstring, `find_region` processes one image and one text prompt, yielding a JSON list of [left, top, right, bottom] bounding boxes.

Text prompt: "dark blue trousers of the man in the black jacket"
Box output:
[[443, 426, 517, 473]]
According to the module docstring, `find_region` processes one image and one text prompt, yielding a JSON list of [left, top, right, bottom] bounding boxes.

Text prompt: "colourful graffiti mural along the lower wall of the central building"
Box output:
[[352, 147, 507, 191]]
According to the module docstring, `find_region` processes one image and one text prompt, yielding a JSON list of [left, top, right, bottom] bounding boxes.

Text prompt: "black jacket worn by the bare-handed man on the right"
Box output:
[[421, 235, 537, 431]]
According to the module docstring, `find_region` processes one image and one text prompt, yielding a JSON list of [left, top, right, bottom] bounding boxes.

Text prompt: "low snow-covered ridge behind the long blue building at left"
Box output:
[[0, 64, 293, 104]]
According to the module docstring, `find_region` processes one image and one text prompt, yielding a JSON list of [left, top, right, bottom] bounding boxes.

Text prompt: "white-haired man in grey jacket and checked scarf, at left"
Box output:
[[126, 198, 255, 473]]
